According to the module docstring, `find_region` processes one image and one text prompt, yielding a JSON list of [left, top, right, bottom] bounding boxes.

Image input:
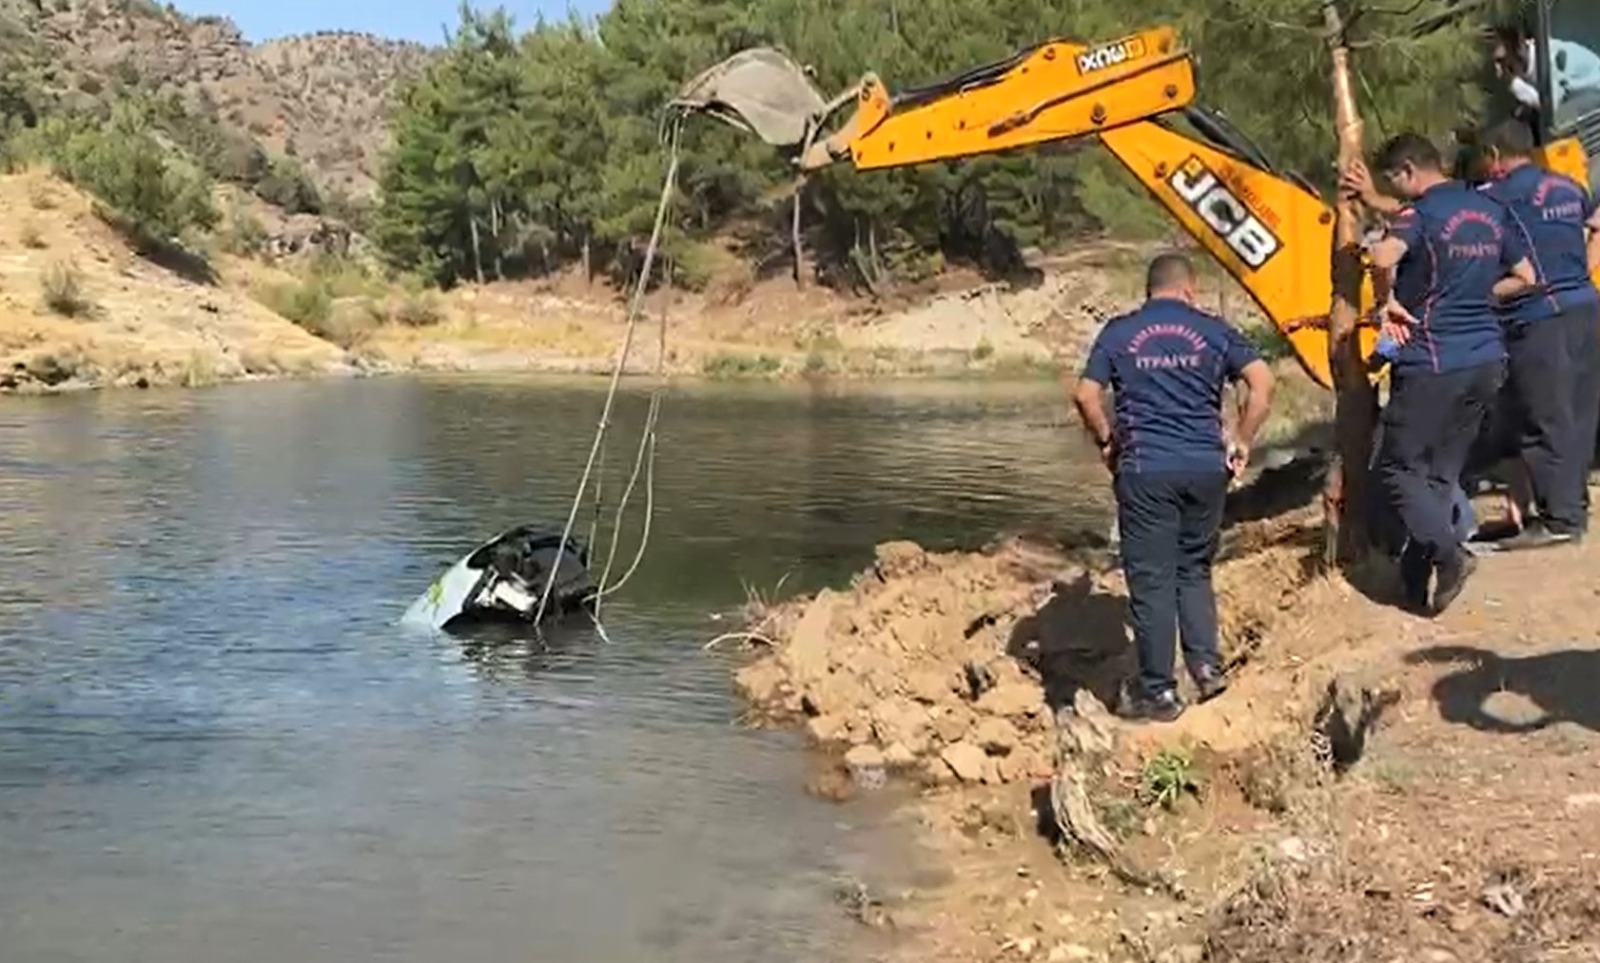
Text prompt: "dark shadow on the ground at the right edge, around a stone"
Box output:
[[1406, 645, 1600, 734]]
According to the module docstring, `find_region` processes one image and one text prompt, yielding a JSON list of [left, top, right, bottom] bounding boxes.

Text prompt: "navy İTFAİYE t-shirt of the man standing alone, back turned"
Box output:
[[1083, 298, 1261, 472]]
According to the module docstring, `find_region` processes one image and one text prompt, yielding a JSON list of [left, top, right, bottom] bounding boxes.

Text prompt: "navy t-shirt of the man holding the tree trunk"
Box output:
[[1389, 181, 1528, 371]]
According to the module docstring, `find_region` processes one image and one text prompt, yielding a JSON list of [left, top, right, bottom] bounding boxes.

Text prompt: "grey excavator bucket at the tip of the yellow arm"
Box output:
[[672, 46, 827, 149]]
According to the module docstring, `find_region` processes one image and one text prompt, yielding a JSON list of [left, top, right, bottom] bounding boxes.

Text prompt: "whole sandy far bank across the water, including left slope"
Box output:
[[0, 170, 1299, 395]]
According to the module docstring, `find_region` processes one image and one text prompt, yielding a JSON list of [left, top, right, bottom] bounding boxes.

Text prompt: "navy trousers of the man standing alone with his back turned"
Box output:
[[1115, 470, 1227, 696]]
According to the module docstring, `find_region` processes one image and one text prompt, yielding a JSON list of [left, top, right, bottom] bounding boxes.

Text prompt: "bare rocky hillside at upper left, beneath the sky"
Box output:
[[12, 0, 430, 197]]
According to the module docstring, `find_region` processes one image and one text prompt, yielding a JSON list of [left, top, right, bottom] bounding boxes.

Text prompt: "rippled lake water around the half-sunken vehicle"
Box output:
[[0, 372, 1104, 963]]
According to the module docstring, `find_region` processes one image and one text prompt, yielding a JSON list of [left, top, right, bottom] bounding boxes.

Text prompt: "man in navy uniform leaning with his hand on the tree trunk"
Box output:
[[1344, 133, 1536, 614]]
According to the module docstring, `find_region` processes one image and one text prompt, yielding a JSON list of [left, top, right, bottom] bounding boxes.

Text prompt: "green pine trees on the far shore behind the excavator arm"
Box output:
[[378, 0, 1510, 293]]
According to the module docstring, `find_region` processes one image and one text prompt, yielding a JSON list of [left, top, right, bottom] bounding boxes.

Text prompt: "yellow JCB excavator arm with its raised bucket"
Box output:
[[674, 27, 1587, 387]]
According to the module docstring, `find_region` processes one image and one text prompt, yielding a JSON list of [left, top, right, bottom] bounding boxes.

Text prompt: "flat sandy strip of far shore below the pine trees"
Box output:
[[357, 246, 1171, 378]]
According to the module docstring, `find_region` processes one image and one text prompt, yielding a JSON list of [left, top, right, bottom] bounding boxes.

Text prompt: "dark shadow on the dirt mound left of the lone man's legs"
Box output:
[[1006, 574, 1136, 709]]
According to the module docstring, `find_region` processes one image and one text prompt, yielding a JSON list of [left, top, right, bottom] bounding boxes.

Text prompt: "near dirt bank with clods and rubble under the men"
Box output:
[[738, 479, 1600, 963]]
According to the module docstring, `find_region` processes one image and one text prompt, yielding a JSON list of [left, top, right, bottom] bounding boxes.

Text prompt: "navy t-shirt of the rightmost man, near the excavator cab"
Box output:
[[1483, 163, 1600, 325]]
